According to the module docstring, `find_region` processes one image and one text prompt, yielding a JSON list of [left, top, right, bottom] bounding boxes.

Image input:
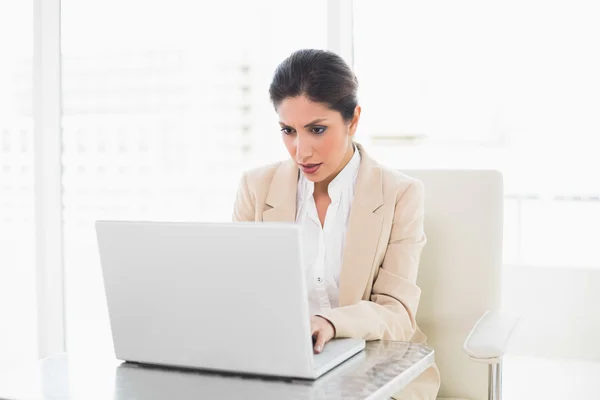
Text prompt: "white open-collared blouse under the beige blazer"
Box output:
[[296, 148, 360, 315]]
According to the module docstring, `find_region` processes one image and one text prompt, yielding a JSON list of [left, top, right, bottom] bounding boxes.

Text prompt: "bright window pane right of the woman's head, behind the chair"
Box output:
[[354, 0, 600, 267]]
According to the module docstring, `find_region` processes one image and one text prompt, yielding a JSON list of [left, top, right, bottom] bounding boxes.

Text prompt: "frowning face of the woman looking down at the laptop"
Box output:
[[277, 96, 360, 183]]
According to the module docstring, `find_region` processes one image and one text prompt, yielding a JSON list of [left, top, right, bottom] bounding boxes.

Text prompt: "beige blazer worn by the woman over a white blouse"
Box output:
[[233, 144, 440, 399]]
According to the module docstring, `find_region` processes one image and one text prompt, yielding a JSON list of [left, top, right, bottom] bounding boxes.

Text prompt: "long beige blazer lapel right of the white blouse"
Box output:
[[339, 145, 383, 307]]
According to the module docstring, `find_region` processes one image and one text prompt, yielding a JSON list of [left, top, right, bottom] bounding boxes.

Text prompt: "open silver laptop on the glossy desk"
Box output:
[[96, 221, 365, 379]]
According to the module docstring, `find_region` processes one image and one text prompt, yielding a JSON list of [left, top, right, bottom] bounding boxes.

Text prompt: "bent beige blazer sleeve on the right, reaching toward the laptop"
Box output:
[[319, 180, 426, 341]]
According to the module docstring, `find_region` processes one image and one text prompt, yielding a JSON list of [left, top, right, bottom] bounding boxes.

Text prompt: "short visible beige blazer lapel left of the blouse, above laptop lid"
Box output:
[[263, 160, 299, 222]]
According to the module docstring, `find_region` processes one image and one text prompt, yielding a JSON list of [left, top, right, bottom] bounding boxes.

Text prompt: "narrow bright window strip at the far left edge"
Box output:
[[0, 1, 37, 362]]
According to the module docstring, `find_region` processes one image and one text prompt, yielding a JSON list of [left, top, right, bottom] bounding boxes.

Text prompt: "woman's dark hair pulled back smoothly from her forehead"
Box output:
[[269, 49, 358, 122]]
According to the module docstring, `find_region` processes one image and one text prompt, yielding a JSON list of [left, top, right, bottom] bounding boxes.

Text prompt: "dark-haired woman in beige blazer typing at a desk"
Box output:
[[233, 50, 439, 399]]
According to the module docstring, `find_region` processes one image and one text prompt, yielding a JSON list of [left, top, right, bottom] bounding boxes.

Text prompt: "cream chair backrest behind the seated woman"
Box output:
[[403, 170, 503, 400]]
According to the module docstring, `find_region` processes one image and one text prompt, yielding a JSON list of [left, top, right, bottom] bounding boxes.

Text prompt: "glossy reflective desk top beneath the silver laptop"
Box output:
[[0, 341, 434, 400]]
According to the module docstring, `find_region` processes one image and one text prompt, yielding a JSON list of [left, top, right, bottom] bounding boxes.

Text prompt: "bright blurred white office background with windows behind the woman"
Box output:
[[0, 0, 600, 399]]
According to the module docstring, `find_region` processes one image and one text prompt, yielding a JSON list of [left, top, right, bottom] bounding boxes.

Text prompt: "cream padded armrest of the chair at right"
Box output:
[[464, 311, 520, 364]]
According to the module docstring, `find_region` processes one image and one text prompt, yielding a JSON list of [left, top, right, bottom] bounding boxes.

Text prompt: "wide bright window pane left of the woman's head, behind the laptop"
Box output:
[[62, 0, 327, 351]]
